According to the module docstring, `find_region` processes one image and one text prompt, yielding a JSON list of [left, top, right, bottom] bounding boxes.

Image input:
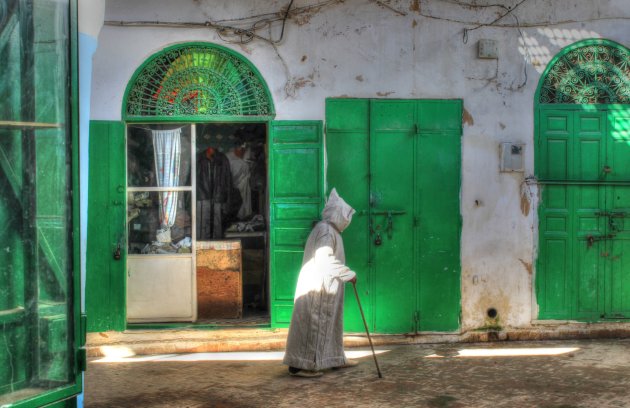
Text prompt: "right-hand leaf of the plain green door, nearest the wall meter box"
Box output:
[[415, 100, 462, 331]]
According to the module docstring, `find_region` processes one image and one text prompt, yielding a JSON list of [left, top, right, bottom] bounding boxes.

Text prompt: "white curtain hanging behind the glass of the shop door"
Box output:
[[151, 128, 182, 230]]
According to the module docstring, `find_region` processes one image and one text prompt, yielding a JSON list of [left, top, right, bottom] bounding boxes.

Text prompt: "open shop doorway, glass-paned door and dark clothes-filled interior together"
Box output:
[[127, 123, 269, 325]]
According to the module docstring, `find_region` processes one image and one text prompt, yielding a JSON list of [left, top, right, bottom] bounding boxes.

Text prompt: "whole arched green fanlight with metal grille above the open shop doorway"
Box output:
[[121, 42, 275, 122]]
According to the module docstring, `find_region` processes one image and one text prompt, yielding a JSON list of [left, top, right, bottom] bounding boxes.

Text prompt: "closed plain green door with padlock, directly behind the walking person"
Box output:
[[326, 99, 462, 333]]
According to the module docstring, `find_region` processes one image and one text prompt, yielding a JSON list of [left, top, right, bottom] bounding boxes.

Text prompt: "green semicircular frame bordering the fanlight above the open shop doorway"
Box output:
[[121, 42, 275, 122]]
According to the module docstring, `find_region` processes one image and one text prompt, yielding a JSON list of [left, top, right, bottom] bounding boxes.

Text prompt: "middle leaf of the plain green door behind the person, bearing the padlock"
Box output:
[[372, 100, 418, 333]]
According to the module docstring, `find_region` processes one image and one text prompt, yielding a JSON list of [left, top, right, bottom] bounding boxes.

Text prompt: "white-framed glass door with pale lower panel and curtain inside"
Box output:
[[127, 124, 197, 323]]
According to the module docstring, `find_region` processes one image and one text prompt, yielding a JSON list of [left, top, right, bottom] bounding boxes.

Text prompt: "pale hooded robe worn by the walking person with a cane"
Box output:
[[284, 189, 355, 370]]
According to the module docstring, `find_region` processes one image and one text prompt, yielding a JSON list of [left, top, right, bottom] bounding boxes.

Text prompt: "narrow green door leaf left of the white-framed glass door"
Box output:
[[85, 121, 127, 332]]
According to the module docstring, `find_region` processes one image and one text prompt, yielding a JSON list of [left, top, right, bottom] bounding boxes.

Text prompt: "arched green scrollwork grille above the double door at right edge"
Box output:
[[539, 44, 630, 104]]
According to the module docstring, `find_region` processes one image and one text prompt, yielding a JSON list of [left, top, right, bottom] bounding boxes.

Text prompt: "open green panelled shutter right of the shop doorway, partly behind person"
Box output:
[[269, 121, 324, 327]]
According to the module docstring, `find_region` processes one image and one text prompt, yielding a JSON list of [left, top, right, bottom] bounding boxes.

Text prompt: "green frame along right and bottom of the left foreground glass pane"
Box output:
[[10, 0, 87, 408]]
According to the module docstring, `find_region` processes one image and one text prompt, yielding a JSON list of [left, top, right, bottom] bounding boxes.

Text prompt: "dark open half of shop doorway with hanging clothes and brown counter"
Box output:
[[195, 123, 269, 323]]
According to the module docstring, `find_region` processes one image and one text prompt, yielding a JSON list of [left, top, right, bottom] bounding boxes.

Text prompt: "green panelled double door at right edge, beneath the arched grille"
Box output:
[[536, 105, 630, 321]]
